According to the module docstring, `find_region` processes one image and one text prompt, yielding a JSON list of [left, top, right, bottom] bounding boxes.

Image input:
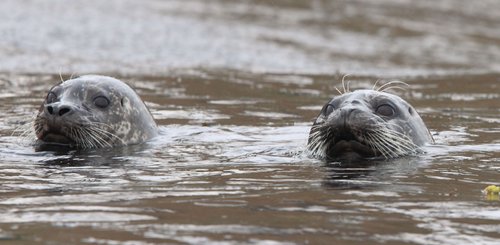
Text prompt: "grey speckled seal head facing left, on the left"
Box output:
[[34, 75, 158, 148]]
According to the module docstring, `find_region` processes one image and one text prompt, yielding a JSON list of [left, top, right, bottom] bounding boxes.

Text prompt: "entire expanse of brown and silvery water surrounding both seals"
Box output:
[[0, 0, 500, 244]]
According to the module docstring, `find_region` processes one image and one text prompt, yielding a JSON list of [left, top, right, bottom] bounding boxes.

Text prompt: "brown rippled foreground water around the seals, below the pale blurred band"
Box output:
[[0, 73, 500, 244]]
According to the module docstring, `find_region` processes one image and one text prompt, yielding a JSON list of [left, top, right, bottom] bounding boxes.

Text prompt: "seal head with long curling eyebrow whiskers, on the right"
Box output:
[[308, 90, 433, 160]]
